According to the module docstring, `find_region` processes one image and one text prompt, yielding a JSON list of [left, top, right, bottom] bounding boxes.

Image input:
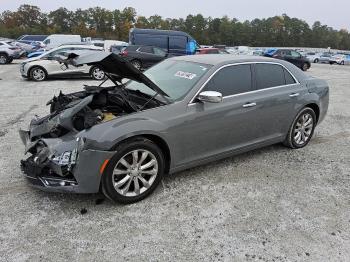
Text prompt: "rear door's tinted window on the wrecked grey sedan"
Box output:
[[255, 64, 286, 89]]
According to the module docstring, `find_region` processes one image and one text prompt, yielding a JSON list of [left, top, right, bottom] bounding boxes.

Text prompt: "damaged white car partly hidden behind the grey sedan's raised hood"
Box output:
[[20, 45, 105, 81]]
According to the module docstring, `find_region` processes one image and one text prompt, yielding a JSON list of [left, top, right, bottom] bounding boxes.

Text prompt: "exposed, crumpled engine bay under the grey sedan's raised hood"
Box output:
[[30, 82, 163, 144]]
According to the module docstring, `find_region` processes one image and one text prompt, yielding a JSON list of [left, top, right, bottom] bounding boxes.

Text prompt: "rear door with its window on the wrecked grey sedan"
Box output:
[[251, 63, 308, 138]]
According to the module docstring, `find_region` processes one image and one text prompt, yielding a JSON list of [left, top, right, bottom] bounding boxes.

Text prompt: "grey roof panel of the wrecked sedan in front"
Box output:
[[171, 54, 281, 65]]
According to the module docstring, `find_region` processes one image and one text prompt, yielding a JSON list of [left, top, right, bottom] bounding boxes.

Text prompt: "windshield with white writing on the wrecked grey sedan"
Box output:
[[126, 60, 212, 101]]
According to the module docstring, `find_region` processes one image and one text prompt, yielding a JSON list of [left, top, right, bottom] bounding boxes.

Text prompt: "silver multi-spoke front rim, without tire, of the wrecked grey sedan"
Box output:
[[112, 149, 158, 197]]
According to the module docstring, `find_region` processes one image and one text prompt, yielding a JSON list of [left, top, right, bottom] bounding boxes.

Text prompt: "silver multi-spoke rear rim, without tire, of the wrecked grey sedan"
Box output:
[[293, 113, 314, 146]]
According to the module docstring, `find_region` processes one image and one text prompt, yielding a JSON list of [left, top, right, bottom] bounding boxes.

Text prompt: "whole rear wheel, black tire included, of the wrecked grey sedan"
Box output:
[[283, 107, 317, 149]]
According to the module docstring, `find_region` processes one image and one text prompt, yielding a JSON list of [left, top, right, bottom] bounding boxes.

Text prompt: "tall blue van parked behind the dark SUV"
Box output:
[[129, 28, 200, 56]]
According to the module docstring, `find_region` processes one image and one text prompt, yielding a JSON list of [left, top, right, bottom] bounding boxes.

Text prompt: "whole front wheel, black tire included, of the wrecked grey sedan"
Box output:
[[101, 138, 165, 204]]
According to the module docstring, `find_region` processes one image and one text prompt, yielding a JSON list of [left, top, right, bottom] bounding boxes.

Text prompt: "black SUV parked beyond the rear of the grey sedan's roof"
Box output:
[[265, 49, 311, 71]]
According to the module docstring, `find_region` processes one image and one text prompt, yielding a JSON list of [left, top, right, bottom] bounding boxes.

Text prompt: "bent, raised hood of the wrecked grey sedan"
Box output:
[[67, 52, 168, 96]]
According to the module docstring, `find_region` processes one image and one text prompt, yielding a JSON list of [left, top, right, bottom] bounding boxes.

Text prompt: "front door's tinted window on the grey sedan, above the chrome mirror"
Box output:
[[203, 65, 252, 96]]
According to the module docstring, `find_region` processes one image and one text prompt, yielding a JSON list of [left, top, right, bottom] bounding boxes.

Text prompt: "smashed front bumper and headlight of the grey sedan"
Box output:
[[19, 130, 115, 193]]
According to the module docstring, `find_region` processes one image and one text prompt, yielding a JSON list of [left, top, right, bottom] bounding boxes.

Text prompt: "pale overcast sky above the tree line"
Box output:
[[0, 0, 350, 31]]
